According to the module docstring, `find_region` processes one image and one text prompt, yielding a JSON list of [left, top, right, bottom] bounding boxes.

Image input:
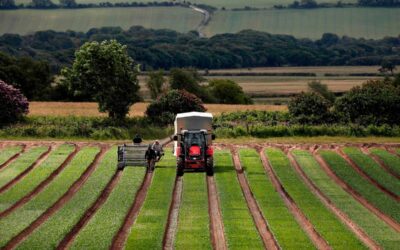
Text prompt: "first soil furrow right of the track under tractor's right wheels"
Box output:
[[231, 150, 280, 249]]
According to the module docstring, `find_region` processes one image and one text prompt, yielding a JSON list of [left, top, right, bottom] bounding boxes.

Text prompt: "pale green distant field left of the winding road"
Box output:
[[0, 7, 202, 34]]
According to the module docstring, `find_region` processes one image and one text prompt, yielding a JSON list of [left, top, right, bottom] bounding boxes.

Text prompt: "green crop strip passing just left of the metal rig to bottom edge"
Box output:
[[18, 148, 117, 249]]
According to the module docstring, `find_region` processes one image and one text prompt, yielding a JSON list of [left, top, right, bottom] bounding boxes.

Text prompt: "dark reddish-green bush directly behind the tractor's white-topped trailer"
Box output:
[[146, 90, 206, 125]]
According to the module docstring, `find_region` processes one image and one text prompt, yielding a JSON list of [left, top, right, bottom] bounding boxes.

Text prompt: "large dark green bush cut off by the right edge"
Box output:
[[335, 80, 400, 125]]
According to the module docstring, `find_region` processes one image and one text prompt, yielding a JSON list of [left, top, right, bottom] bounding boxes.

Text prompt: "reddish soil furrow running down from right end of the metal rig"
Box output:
[[110, 169, 153, 250]]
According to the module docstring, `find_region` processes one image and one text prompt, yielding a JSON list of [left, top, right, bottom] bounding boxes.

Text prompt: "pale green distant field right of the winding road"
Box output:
[[204, 8, 400, 39]]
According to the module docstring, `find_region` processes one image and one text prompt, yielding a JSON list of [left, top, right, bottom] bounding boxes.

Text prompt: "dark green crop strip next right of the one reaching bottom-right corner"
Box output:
[[320, 150, 400, 225]]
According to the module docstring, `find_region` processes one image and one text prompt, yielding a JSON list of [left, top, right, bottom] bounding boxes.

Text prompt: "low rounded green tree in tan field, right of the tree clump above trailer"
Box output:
[[208, 79, 253, 104]]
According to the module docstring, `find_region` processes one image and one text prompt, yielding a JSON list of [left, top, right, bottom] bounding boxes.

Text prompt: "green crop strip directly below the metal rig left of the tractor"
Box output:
[[70, 167, 145, 249]]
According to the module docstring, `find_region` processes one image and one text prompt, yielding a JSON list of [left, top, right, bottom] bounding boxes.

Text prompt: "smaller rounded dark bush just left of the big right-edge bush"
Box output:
[[289, 92, 330, 124]]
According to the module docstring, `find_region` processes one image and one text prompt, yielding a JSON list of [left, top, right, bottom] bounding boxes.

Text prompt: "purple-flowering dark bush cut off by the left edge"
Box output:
[[0, 80, 29, 124]]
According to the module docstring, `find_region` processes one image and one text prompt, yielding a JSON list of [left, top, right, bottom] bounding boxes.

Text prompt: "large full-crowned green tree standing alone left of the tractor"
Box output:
[[62, 40, 140, 119]]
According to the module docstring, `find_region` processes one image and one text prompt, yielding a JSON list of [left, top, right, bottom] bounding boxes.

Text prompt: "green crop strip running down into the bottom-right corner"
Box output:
[[293, 150, 400, 249]]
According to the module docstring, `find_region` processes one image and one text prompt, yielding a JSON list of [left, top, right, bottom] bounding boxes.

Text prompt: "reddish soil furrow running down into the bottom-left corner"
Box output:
[[3, 146, 107, 250]]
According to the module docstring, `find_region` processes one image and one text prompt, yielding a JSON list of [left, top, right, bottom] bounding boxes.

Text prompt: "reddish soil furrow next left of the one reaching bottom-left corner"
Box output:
[[0, 146, 80, 219]]
